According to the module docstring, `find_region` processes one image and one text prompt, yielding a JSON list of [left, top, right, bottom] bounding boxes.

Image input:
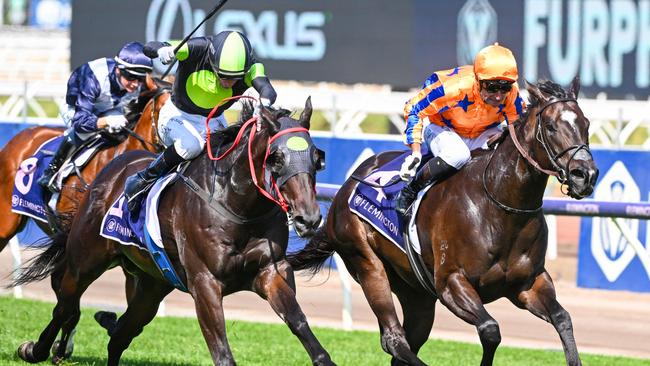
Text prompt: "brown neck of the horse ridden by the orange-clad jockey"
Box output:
[[486, 126, 548, 209]]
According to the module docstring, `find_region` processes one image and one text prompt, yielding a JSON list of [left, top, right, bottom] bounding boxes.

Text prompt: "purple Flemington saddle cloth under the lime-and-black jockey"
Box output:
[[100, 172, 187, 292]]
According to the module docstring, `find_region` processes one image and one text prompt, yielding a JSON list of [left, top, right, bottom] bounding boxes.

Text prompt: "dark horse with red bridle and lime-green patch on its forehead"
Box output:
[[18, 99, 333, 365]]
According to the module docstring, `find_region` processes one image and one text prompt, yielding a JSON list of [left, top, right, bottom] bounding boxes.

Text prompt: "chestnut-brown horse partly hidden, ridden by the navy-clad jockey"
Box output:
[[0, 78, 169, 251]]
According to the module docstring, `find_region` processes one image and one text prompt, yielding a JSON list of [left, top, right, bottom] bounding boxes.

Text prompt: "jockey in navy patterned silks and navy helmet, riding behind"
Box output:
[[38, 42, 153, 192]]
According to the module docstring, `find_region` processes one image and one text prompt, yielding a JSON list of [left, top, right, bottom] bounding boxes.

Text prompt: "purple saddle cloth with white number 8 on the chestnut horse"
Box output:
[[11, 136, 104, 223]]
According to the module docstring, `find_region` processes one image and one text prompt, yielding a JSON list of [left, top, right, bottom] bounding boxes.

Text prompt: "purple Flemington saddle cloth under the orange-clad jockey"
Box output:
[[348, 151, 432, 254]]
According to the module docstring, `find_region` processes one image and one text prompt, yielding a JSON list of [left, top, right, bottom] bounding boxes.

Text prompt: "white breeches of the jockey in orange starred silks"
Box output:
[[424, 123, 503, 169]]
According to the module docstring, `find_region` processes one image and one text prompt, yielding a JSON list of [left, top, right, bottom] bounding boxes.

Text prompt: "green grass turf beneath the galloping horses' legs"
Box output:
[[0, 296, 650, 366]]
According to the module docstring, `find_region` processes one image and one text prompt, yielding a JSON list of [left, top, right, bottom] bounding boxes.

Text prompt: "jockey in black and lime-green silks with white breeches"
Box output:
[[124, 31, 277, 210]]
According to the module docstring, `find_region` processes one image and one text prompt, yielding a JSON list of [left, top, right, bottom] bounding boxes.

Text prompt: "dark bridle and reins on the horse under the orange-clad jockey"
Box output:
[[483, 98, 593, 213]]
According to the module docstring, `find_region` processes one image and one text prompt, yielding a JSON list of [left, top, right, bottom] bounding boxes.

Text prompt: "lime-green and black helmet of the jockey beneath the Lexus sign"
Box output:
[[209, 31, 252, 79]]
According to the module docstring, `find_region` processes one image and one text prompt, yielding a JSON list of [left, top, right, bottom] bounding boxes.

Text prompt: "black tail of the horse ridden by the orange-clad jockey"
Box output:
[[287, 225, 334, 275]]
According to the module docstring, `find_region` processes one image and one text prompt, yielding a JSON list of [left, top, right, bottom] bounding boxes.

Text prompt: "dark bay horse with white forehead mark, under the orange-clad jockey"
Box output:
[[287, 79, 598, 366]]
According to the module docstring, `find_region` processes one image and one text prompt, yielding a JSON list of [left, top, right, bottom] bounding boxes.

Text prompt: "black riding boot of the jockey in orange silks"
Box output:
[[395, 156, 458, 222]]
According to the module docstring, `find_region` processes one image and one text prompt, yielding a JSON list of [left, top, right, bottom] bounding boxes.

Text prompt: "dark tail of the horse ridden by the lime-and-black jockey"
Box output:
[[7, 233, 67, 287]]
